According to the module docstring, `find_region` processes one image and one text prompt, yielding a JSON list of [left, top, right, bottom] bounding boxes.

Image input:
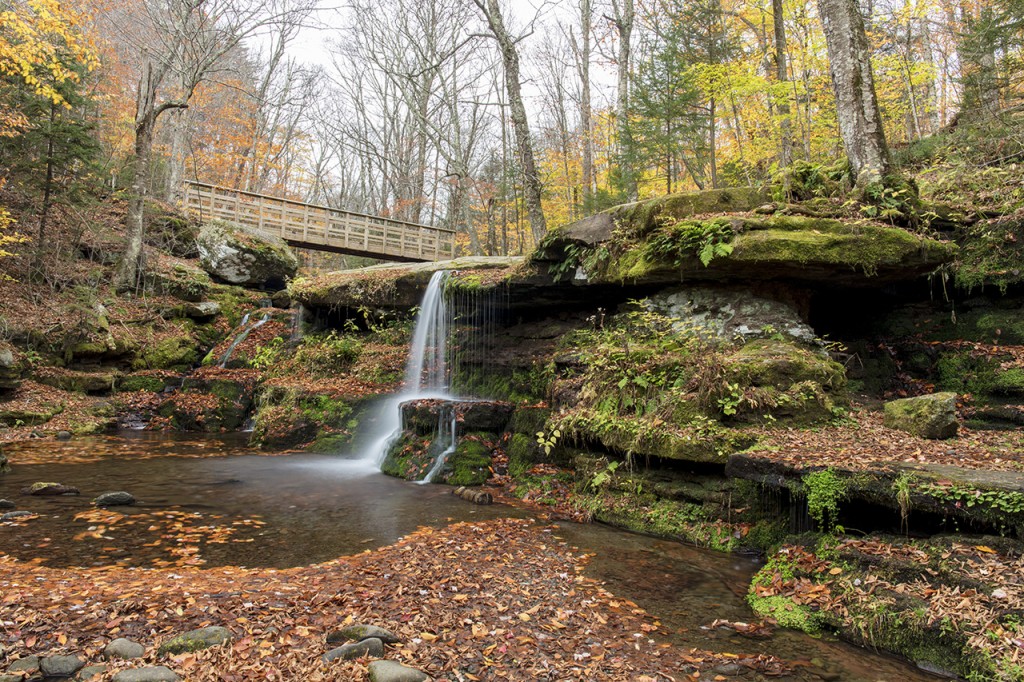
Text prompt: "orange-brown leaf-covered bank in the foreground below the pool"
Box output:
[[0, 519, 788, 682]]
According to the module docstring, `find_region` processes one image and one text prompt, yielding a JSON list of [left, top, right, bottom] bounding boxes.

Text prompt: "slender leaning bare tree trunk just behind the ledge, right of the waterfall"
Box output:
[[477, 0, 548, 242]]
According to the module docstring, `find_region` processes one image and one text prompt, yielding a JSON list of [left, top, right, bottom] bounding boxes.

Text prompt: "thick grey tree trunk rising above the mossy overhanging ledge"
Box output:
[[818, 0, 892, 187]]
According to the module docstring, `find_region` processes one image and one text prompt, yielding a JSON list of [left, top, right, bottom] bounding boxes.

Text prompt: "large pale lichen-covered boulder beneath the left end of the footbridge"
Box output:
[[197, 220, 299, 287]]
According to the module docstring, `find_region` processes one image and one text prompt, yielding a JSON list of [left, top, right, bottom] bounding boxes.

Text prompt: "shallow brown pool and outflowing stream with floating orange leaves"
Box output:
[[0, 432, 936, 682]]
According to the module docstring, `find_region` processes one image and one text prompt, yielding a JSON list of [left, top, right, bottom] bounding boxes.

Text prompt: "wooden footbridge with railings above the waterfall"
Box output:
[[184, 181, 455, 262]]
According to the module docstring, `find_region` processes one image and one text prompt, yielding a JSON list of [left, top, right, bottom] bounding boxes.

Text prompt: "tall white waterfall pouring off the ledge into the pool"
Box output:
[[366, 270, 456, 473]]
